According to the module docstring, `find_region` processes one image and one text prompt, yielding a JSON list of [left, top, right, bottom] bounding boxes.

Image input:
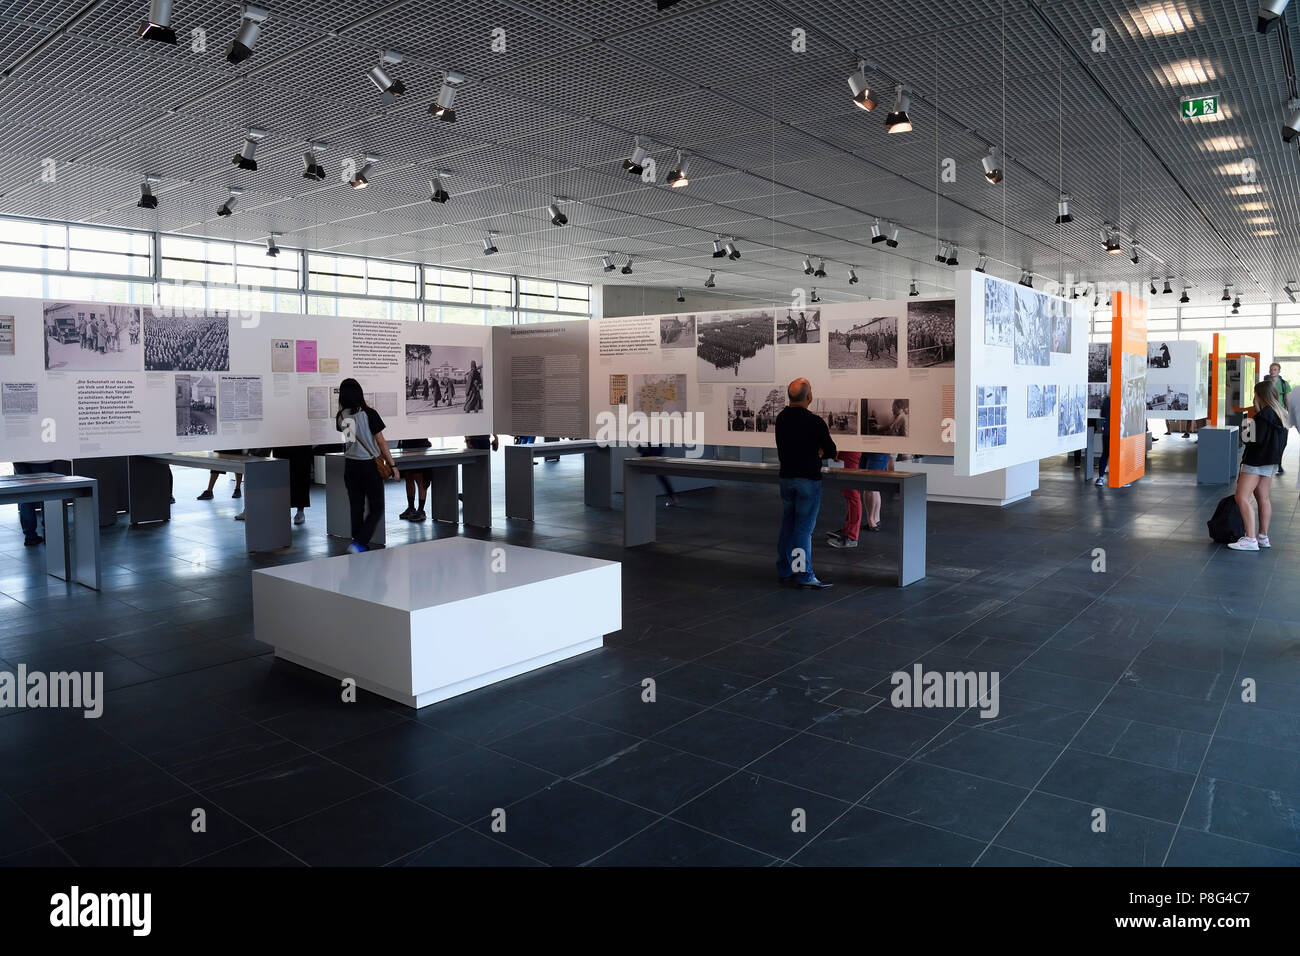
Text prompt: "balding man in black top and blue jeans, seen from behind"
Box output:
[[776, 378, 839, 588]]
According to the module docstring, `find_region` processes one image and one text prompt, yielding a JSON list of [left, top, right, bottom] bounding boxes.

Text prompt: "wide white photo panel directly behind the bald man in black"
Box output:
[[590, 298, 956, 455]]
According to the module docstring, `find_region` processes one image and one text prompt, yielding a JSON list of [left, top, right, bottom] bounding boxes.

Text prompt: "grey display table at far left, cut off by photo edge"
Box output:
[[0, 472, 100, 591]]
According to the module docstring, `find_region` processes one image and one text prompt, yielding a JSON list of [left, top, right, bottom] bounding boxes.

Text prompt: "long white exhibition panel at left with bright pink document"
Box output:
[[0, 298, 493, 460]]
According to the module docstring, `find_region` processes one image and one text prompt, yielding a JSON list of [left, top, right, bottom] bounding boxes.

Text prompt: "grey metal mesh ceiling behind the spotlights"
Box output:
[[0, 0, 1300, 302]]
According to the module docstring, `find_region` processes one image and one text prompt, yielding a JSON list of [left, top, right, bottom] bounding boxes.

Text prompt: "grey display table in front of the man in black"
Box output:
[[623, 458, 926, 588]]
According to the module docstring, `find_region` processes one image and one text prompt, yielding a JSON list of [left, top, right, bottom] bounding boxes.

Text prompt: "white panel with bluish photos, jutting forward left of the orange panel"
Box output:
[[954, 271, 1088, 476]]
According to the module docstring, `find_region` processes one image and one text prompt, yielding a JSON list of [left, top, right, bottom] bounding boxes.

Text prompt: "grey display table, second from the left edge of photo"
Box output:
[[129, 451, 293, 551]]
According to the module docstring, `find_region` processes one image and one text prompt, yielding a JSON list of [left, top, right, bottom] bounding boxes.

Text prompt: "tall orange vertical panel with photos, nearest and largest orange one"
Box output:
[[1109, 291, 1147, 488]]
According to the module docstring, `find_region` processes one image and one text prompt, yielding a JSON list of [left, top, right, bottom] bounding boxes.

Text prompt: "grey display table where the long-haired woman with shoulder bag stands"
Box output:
[[325, 449, 491, 545]]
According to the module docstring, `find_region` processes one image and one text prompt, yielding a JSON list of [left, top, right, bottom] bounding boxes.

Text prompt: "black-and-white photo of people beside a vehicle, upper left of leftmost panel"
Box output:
[[46, 302, 144, 372]]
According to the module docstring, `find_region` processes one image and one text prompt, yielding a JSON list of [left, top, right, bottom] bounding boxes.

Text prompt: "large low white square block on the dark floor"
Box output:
[[252, 537, 623, 708]]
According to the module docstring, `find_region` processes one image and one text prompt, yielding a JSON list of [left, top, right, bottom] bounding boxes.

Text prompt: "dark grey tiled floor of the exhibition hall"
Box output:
[[0, 438, 1300, 866]]
